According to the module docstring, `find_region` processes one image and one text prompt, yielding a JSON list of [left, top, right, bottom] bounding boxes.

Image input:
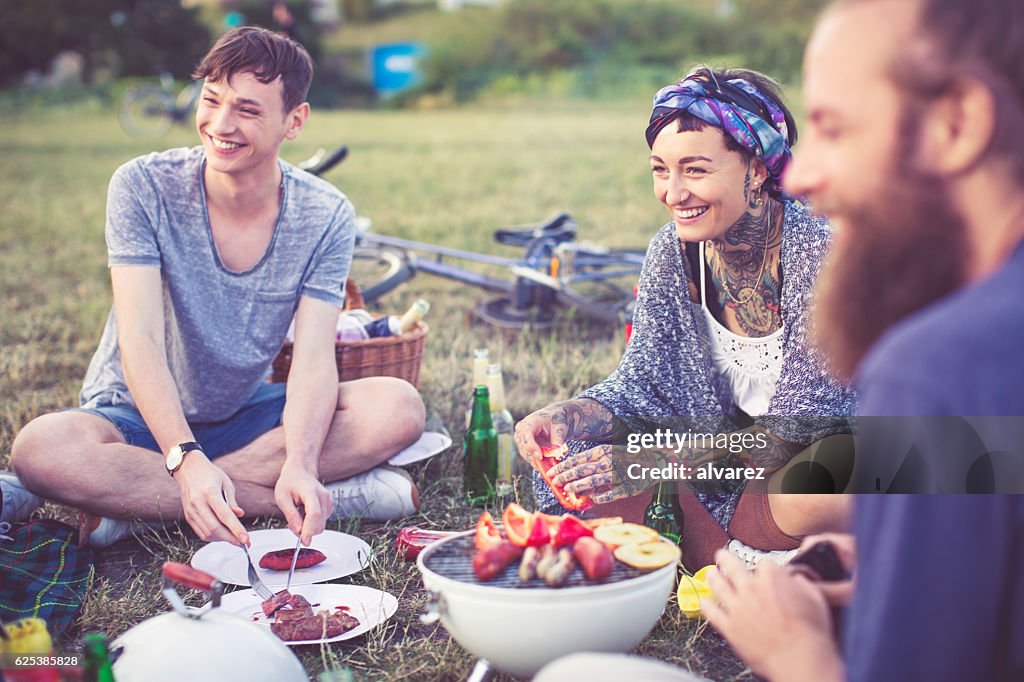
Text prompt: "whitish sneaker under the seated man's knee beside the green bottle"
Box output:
[[327, 464, 420, 521]]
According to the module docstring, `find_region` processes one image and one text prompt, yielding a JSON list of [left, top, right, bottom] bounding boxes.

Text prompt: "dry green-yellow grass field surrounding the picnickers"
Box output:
[[0, 99, 744, 680]]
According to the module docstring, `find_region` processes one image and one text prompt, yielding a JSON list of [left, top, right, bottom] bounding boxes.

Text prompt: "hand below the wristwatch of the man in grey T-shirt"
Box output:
[[174, 451, 249, 545]]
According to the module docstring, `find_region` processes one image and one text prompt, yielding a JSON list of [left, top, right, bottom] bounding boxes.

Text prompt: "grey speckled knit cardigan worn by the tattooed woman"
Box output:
[[534, 199, 856, 520]]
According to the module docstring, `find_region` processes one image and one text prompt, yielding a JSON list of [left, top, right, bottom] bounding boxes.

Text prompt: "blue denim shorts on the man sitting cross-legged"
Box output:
[[73, 384, 285, 460]]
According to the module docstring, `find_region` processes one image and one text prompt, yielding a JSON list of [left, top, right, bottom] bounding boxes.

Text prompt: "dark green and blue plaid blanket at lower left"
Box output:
[[0, 519, 92, 638]]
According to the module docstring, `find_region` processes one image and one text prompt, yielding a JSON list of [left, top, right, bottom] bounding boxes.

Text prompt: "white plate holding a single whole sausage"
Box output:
[[190, 528, 370, 591]]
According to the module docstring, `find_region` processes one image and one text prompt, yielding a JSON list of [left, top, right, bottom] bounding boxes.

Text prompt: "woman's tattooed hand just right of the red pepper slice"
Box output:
[[548, 445, 656, 504]]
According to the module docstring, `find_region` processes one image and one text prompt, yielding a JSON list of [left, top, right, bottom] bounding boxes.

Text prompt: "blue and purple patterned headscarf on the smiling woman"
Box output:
[[646, 74, 793, 198]]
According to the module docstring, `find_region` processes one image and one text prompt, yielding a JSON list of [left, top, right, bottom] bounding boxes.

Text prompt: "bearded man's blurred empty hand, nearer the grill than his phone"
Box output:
[[701, 550, 844, 682]]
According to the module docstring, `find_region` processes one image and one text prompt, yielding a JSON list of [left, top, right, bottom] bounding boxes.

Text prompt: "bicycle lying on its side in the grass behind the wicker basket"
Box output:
[[302, 147, 645, 329]]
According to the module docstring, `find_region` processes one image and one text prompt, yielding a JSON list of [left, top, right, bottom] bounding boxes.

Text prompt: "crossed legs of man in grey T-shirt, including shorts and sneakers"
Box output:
[[11, 377, 424, 545]]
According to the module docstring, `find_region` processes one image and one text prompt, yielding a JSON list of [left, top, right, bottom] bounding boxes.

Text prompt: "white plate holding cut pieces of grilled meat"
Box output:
[[220, 585, 398, 646]]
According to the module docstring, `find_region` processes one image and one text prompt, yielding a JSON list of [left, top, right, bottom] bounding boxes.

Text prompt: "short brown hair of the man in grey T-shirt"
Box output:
[[193, 26, 313, 112]]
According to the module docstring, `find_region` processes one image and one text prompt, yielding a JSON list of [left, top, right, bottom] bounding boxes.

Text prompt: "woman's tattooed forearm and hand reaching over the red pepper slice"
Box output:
[[515, 398, 630, 460]]
